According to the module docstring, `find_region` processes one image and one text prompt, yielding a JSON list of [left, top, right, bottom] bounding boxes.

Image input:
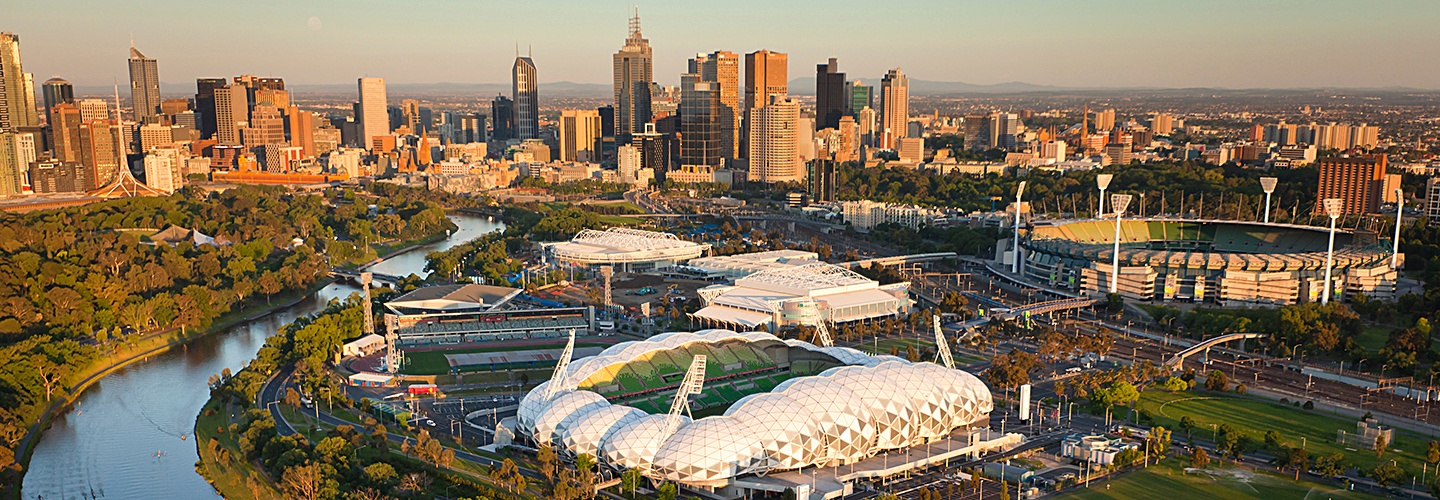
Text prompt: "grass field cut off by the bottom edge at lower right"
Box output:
[[1056, 458, 1374, 500]]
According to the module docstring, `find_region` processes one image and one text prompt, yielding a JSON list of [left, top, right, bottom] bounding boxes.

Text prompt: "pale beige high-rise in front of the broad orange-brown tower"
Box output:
[[748, 95, 805, 183]]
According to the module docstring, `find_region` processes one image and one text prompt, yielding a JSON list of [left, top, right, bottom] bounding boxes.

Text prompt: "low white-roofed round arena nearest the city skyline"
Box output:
[[543, 228, 710, 272]]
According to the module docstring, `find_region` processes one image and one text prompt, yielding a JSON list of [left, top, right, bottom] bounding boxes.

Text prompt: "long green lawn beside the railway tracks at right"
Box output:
[[1120, 390, 1428, 471]]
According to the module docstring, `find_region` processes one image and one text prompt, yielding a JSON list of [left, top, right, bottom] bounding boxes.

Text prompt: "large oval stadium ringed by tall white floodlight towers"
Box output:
[[1021, 218, 1397, 305]]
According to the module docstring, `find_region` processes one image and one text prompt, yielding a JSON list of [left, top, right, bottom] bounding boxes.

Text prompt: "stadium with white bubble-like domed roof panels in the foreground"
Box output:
[[514, 330, 1018, 497]]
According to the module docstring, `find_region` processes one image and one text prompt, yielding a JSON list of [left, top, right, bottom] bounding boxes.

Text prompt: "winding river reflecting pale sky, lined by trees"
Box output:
[[22, 215, 504, 500]]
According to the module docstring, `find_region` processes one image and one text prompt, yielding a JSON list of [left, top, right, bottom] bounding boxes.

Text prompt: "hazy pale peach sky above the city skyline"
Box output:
[[11, 0, 1440, 94]]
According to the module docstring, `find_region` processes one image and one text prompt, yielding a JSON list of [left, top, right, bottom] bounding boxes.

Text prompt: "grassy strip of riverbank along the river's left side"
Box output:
[[4, 280, 333, 500]]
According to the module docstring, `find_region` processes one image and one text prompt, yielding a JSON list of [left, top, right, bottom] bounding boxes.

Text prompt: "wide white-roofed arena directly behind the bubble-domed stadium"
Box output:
[[690, 262, 910, 331]]
